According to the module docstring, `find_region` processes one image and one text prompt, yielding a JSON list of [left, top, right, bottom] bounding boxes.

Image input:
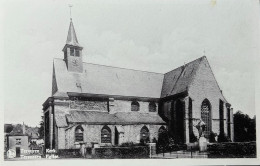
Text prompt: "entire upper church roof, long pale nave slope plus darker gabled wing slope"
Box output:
[[53, 56, 226, 101]]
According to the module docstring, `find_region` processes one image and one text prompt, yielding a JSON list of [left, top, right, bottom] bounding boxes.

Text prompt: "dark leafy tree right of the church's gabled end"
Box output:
[[234, 111, 256, 142]]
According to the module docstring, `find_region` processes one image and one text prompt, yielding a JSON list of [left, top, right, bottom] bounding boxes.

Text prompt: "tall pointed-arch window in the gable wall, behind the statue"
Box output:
[[201, 99, 211, 138]]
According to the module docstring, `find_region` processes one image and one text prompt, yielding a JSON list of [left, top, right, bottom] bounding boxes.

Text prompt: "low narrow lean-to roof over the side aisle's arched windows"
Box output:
[[63, 111, 165, 127]]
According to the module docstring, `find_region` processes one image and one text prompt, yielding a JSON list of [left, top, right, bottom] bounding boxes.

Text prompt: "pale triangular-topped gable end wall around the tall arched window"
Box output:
[[189, 57, 230, 138]]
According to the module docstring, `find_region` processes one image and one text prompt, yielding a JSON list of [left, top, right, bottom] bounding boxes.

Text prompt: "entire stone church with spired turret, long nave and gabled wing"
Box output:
[[43, 20, 233, 150]]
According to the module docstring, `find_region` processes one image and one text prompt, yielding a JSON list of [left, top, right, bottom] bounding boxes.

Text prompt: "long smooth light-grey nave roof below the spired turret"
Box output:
[[53, 59, 164, 98]]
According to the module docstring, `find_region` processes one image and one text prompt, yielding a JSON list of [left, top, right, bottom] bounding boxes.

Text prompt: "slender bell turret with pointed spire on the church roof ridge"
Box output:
[[62, 19, 83, 73]]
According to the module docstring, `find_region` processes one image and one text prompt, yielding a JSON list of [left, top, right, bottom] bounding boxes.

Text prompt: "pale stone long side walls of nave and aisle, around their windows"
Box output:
[[54, 99, 161, 149]]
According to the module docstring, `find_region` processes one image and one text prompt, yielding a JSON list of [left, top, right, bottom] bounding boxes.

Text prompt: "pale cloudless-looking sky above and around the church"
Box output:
[[2, 0, 260, 126]]
